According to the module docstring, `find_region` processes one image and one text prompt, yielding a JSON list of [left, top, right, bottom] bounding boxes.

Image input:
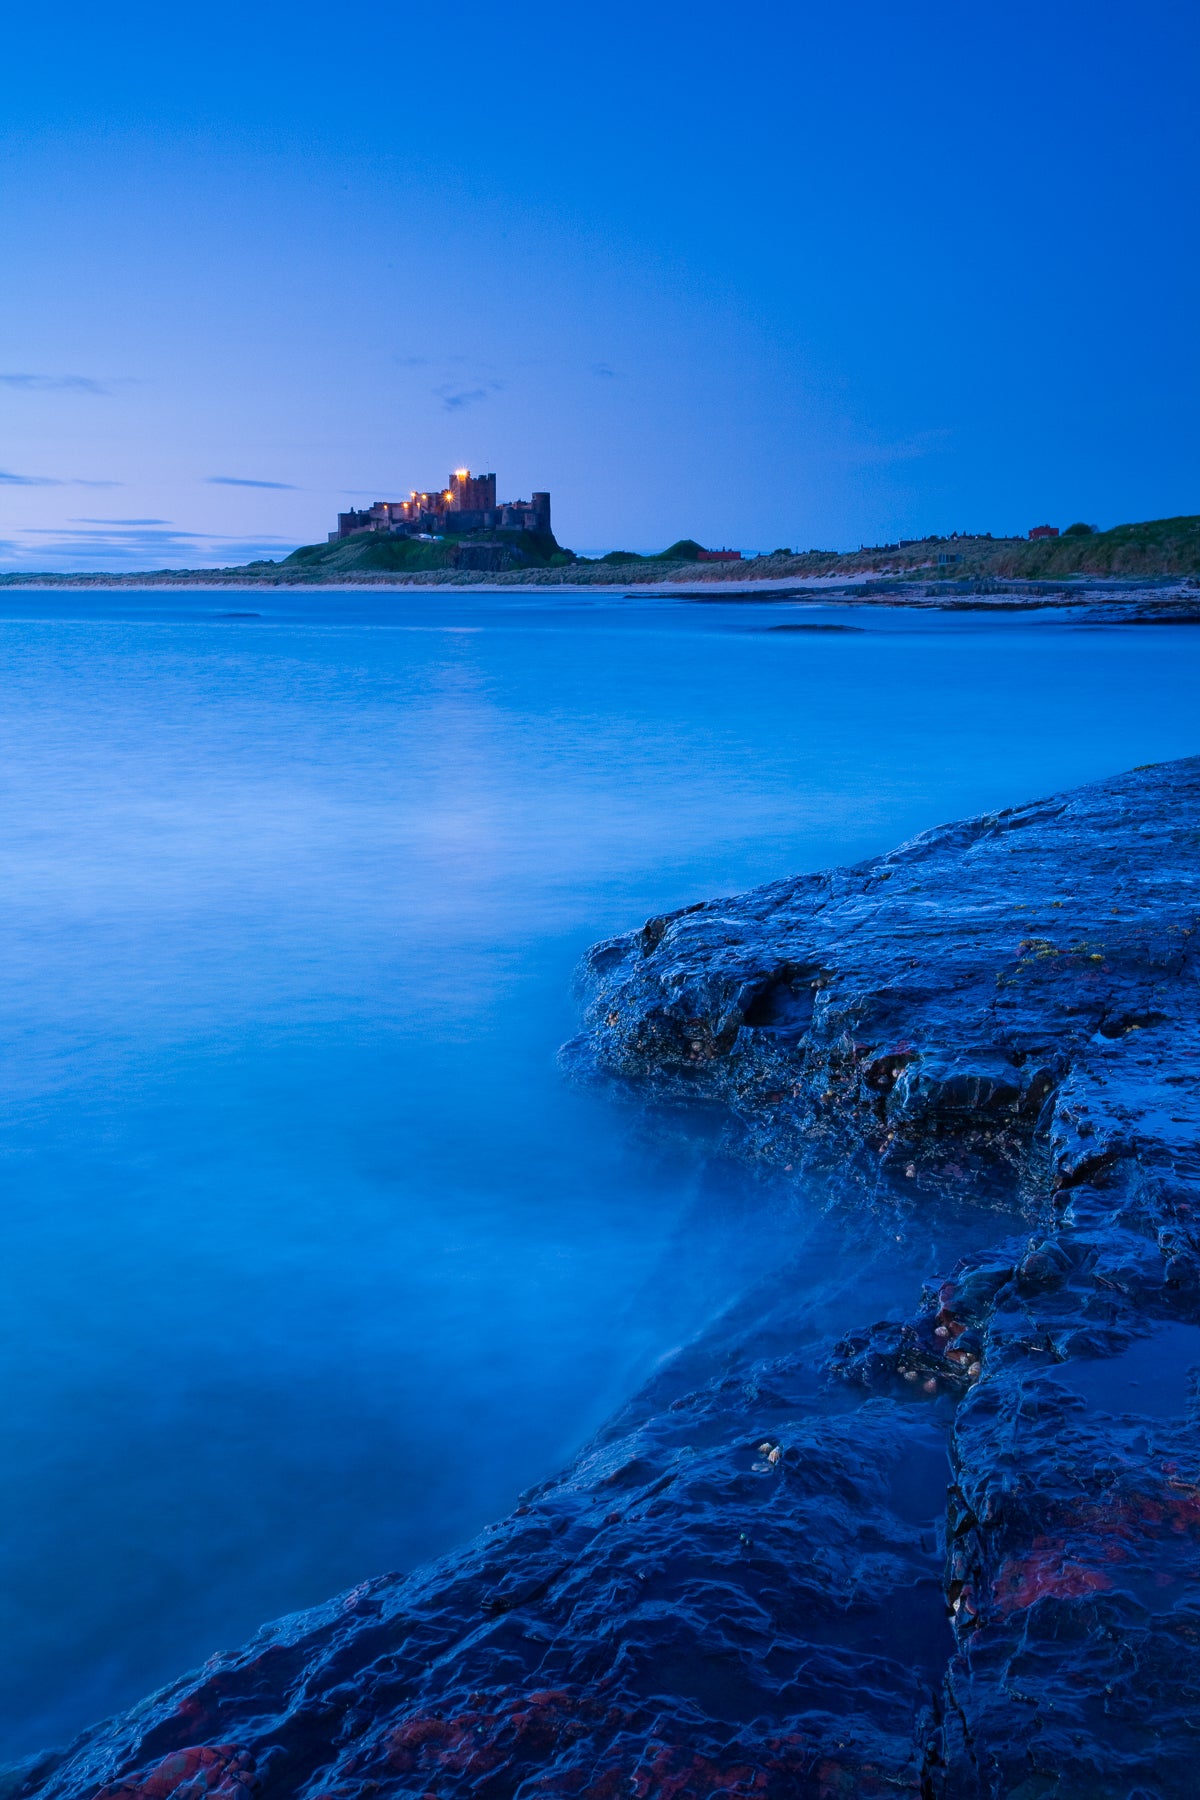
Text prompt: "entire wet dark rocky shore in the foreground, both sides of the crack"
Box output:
[[9, 760, 1200, 1800]]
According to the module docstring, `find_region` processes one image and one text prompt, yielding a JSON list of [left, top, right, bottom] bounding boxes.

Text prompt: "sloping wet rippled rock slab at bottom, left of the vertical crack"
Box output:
[[11, 1357, 952, 1800]]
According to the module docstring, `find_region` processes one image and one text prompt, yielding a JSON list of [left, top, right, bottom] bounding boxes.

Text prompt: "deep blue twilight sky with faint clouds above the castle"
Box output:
[[0, 0, 1200, 569]]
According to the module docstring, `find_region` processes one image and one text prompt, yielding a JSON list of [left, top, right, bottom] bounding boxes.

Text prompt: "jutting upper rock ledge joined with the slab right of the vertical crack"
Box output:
[[572, 760, 1200, 1800]]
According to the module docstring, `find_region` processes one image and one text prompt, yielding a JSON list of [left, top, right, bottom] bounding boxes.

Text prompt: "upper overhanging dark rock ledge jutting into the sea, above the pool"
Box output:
[[567, 760, 1200, 1202]]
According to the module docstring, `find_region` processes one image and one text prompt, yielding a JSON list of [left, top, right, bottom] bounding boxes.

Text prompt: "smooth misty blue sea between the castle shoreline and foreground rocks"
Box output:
[[0, 590, 1200, 1755]]
